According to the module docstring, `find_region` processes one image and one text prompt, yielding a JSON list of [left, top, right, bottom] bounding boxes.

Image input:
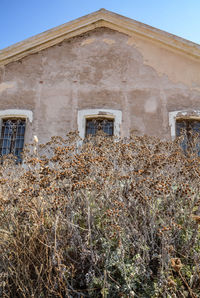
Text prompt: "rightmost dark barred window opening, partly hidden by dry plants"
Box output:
[[176, 119, 200, 156]]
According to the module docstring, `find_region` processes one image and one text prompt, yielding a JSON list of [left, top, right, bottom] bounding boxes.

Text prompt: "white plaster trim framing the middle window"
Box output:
[[77, 109, 122, 139]]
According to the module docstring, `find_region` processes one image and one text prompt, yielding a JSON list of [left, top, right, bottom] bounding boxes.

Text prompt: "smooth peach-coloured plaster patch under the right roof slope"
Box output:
[[126, 36, 200, 90]]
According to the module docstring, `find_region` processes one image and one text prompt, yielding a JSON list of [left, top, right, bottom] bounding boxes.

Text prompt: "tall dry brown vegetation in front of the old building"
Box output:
[[0, 133, 200, 298]]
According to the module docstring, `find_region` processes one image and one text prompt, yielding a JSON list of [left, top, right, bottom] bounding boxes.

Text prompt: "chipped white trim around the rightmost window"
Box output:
[[169, 110, 200, 140]]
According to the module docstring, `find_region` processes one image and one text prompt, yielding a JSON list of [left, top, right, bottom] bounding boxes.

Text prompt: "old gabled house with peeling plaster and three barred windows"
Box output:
[[0, 9, 200, 155]]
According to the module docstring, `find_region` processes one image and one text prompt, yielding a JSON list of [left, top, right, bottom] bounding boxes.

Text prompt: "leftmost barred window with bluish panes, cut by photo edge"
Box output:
[[0, 118, 26, 162]]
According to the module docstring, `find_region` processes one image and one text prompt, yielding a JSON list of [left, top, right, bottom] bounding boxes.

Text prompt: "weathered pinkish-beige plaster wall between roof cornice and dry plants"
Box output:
[[0, 28, 200, 141]]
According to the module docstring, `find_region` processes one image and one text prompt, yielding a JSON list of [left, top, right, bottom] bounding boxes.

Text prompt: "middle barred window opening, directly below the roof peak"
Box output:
[[85, 117, 114, 136]]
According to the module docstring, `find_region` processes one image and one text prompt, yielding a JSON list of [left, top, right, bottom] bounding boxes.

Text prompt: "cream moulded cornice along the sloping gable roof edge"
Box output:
[[0, 9, 200, 65]]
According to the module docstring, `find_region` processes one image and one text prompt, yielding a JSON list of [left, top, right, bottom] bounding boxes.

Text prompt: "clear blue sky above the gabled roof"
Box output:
[[0, 0, 200, 49]]
